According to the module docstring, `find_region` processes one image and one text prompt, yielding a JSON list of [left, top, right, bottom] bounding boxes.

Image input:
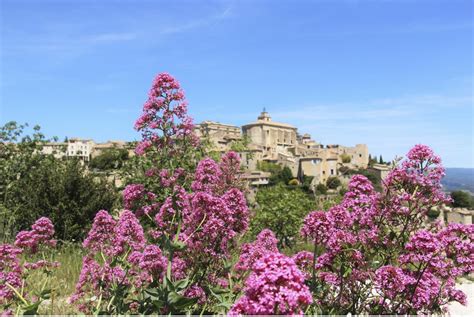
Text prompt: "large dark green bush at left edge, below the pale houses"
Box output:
[[0, 122, 118, 240]]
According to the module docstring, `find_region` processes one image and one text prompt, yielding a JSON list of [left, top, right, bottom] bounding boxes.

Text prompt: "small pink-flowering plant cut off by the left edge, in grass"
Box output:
[[0, 217, 59, 315]]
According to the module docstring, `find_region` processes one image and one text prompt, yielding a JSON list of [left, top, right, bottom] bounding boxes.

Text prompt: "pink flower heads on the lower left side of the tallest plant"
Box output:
[[70, 210, 152, 312]]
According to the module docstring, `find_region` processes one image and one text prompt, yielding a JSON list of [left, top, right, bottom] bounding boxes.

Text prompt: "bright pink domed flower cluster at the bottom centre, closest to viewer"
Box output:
[[229, 252, 313, 315]]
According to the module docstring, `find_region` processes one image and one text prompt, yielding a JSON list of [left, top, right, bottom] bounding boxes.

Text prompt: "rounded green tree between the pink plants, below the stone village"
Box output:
[[250, 184, 315, 247]]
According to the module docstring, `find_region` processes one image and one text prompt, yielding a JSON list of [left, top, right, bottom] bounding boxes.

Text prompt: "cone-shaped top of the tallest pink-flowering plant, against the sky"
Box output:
[[123, 73, 204, 198]]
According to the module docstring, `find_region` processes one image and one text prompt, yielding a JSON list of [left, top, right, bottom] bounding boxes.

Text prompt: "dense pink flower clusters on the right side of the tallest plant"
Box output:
[[181, 153, 249, 262]]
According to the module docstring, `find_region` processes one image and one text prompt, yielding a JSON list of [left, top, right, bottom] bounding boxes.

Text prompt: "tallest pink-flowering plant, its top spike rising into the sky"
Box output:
[[71, 74, 249, 314]]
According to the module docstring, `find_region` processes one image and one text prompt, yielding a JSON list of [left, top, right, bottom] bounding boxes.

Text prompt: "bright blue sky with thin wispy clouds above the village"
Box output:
[[0, 0, 474, 167]]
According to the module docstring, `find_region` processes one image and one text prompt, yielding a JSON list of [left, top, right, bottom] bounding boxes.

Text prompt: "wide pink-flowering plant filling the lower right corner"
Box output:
[[297, 145, 474, 314]]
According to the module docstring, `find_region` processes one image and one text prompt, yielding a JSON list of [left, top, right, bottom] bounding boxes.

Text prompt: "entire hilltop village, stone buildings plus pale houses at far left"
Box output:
[[43, 110, 388, 186]]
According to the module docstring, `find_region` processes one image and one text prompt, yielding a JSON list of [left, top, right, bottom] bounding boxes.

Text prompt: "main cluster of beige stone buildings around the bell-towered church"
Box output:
[[196, 109, 369, 184]]
